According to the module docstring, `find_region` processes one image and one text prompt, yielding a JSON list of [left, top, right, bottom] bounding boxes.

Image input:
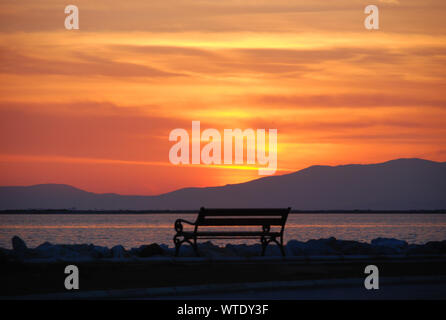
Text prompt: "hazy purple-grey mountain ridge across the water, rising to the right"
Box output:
[[0, 159, 446, 210]]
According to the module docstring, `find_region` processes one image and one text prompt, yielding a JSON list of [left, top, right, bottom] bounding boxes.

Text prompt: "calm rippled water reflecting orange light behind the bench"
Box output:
[[0, 214, 446, 248]]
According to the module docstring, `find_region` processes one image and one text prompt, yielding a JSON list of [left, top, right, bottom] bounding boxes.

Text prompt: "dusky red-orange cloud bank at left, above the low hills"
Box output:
[[0, 101, 190, 161]]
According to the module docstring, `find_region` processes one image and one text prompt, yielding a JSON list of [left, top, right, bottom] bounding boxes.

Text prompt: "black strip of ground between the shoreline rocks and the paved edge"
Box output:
[[0, 256, 446, 298]]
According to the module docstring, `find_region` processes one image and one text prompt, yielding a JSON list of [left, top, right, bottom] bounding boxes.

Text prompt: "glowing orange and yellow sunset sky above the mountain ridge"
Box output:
[[0, 0, 446, 195]]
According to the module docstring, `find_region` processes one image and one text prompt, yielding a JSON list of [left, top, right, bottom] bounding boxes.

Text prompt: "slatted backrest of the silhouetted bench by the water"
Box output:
[[195, 207, 291, 230]]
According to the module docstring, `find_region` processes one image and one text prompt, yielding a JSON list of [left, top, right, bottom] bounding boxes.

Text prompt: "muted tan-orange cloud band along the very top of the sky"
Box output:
[[0, 0, 446, 33]]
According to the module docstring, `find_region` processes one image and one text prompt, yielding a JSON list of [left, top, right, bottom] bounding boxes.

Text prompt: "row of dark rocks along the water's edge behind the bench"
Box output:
[[0, 236, 446, 261]]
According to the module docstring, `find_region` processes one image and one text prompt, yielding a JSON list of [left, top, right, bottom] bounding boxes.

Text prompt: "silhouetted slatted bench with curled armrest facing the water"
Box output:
[[173, 207, 291, 257]]
